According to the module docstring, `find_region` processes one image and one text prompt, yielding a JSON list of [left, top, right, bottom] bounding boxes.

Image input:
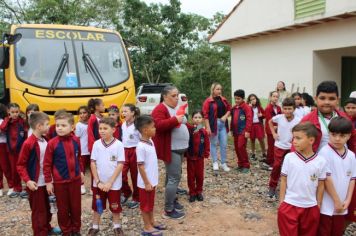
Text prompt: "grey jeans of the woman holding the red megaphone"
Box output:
[[164, 150, 185, 211]]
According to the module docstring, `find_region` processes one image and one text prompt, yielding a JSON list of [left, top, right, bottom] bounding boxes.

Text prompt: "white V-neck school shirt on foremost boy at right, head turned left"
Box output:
[[281, 152, 326, 208]]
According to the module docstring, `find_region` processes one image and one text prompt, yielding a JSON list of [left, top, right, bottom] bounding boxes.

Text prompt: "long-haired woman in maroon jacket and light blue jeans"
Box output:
[[203, 83, 231, 171]]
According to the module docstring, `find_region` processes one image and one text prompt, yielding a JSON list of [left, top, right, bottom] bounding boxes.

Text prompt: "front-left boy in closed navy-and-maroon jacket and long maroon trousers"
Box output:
[[43, 113, 84, 235]]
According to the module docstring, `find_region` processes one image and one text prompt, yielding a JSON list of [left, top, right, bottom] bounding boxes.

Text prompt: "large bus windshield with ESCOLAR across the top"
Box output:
[[15, 28, 129, 89]]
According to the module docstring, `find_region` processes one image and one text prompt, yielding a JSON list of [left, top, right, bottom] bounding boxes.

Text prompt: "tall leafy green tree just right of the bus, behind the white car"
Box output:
[[117, 0, 197, 84]]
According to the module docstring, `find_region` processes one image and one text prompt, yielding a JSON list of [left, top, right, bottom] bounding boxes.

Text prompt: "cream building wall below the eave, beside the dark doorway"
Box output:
[[231, 18, 356, 98]]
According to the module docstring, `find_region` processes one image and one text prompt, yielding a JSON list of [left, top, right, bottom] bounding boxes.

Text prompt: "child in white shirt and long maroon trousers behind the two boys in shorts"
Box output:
[[121, 104, 140, 209]]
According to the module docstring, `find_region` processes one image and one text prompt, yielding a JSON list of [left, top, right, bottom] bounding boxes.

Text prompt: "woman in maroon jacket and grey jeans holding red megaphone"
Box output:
[[152, 85, 189, 219]]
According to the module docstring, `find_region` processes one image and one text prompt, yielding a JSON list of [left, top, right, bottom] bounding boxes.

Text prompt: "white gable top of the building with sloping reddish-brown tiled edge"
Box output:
[[209, 0, 356, 44]]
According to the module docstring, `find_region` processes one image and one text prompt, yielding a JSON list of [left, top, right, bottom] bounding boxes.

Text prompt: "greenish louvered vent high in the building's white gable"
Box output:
[[294, 0, 326, 19]]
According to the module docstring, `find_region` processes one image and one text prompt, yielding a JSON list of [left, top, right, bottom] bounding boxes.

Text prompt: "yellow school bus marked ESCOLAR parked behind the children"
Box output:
[[0, 24, 135, 119]]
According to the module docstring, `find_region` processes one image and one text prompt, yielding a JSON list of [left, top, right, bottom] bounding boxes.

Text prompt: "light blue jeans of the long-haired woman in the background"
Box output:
[[210, 119, 227, 164]]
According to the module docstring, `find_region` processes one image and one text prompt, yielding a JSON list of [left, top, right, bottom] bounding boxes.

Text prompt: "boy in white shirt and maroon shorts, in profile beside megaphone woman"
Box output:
[[135, 115, 166, 235]]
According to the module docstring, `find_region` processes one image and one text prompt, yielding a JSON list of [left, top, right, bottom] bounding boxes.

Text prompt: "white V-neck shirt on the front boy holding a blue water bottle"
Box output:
[[91, 138, 125, 190]]
